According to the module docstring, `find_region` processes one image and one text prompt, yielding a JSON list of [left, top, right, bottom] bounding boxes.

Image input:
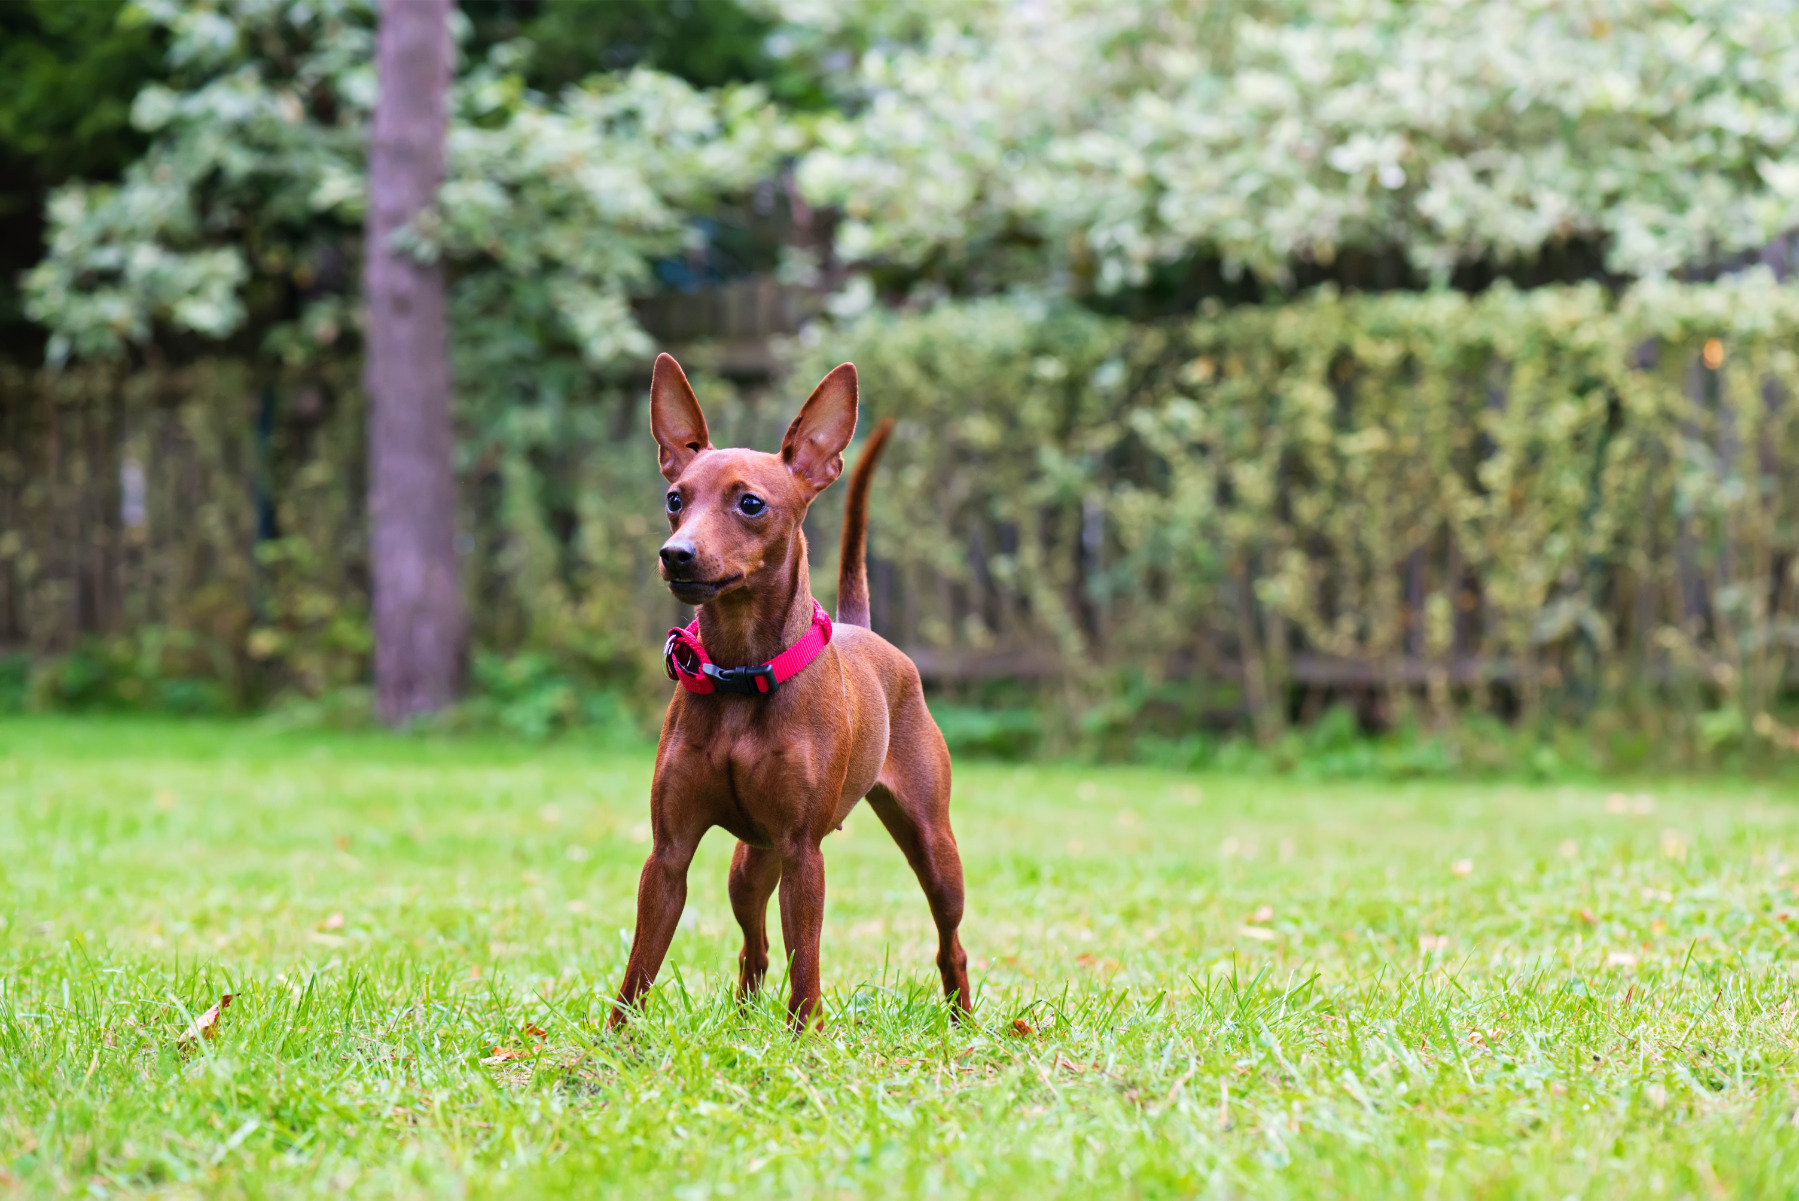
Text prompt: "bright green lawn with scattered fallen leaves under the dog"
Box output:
[[0, 719, 1799, 1197]]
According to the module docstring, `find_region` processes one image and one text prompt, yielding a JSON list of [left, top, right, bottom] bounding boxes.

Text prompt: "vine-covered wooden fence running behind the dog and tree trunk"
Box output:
[[0, 280, 1799, 755]]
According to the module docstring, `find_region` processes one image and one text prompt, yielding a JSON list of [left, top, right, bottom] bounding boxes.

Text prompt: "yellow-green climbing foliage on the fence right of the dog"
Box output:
[[799, 273, 1799, 753]]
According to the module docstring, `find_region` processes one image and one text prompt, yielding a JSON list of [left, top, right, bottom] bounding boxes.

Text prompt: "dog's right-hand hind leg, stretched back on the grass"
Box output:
[[869, 696, 971, 1012]]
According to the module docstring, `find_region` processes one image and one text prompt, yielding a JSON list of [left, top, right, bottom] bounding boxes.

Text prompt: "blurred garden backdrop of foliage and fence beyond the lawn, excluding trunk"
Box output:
[[0, 0, 1799, 773]]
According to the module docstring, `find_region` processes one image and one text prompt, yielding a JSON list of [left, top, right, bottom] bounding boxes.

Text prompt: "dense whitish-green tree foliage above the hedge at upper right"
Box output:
[[795, 0, 1799, 295]]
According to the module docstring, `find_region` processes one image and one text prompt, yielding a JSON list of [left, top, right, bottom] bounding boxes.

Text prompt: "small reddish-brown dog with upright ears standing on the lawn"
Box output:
[[612, 354, 970, 1030]]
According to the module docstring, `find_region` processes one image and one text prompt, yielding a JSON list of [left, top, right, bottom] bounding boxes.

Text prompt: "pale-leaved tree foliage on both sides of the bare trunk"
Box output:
[[27, 0, 797, 370]]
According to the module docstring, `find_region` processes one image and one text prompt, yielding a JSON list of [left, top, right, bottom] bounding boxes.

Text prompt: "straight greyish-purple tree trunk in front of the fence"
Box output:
[[363, 0, 468, 725]]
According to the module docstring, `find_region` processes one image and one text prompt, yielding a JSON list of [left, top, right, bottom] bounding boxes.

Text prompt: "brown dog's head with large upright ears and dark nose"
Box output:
[[649, 354, 856, 604]]
